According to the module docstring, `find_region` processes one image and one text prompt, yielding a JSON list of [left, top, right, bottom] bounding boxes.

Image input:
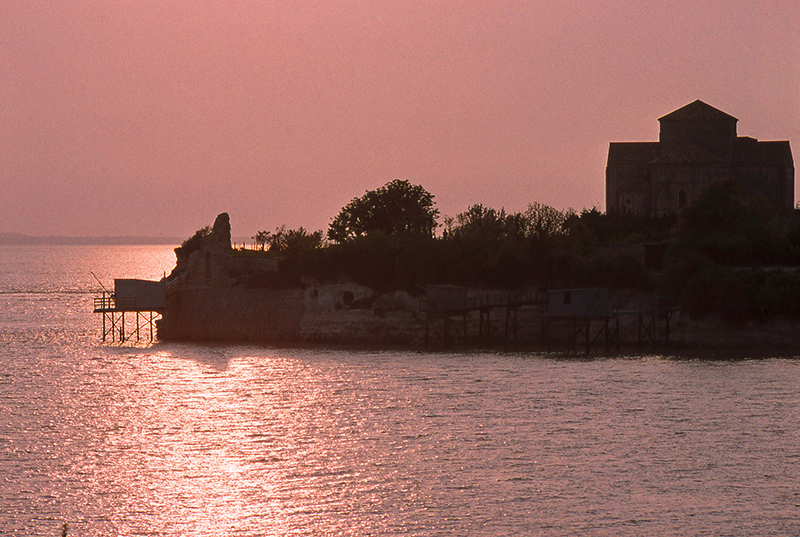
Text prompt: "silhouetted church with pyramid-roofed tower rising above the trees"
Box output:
[[606, 100, 794, 216]]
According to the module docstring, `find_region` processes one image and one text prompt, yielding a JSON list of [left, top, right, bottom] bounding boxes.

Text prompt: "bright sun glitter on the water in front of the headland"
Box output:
[[96, 349, 291, 535]]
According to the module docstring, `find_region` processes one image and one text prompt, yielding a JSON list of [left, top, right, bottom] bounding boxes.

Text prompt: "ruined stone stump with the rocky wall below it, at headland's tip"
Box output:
[[158, 213, 425, 345]]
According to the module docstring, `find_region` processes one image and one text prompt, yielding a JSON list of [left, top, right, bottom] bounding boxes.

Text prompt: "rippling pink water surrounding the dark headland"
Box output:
[[0, 246, 800, 536]]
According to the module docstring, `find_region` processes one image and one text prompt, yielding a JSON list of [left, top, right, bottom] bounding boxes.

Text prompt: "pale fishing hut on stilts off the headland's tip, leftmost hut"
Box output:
[[92, 274, 166, 343]]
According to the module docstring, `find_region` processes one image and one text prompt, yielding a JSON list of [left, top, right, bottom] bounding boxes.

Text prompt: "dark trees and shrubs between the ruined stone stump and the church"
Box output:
[[234, 180, 664, 294]]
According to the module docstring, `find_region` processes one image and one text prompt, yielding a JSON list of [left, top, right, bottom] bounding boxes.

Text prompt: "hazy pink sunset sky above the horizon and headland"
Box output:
[[0, 0, 800, 236]]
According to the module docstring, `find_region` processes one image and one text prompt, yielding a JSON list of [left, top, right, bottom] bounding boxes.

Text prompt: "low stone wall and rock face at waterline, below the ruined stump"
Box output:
[[158, 284, 425, 345]]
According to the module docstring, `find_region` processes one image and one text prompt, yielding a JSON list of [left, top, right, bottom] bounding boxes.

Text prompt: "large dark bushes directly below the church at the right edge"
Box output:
[[658, 181, 800, 322]]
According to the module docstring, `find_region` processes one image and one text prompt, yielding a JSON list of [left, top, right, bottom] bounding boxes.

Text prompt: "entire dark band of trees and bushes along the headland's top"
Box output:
[[181, 180, 800, 320]]
